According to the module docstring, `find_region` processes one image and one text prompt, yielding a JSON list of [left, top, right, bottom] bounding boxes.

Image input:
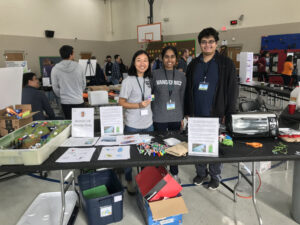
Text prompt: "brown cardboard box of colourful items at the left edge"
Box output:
[[0, 104, 38, 136]]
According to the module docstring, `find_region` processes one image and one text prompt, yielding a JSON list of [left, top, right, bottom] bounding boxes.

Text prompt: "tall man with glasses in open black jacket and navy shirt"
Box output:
[[184, 27, 238, 190]]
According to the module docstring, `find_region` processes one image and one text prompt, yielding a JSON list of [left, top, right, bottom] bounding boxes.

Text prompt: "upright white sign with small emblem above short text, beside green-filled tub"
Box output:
[[72, 108, 94, 137]]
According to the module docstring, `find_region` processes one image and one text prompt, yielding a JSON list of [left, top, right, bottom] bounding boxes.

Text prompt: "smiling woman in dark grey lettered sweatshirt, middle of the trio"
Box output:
[[152, 46, 186, 183]]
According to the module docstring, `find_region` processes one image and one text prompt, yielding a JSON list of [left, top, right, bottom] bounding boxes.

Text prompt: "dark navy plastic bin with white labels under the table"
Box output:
[[78, 170, 124, 225]]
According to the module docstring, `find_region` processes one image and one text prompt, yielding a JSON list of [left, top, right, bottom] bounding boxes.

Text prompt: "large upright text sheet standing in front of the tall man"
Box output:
[[188, 117, 219, 157]]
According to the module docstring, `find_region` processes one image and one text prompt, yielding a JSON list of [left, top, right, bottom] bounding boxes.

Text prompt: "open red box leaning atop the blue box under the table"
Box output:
[[135, 166, 182, 201]]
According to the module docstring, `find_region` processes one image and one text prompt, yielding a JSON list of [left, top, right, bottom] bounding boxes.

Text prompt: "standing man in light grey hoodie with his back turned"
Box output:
[[51, 45, 86, 119]]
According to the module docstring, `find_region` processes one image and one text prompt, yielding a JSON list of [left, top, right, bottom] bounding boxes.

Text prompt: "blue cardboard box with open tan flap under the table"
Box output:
[[136, 186, 188, 225]]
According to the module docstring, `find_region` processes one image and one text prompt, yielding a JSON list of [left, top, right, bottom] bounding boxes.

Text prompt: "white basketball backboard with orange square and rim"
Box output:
[[137, 23, 161, 43]]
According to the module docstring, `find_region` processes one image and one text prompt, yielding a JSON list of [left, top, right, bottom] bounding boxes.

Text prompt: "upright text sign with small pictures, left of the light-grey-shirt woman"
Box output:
[[100, 106, 123, 136]]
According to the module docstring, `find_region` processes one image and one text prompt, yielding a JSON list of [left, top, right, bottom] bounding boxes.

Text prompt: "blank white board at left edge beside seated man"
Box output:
[[0, 67, 23, 109]]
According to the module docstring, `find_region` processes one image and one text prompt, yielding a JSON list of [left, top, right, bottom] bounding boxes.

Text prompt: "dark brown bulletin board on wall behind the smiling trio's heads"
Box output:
[[146, 39, 196, 59]]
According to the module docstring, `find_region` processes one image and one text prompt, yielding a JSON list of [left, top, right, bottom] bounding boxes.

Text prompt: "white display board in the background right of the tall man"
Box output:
[[239, 52, 253, 83]]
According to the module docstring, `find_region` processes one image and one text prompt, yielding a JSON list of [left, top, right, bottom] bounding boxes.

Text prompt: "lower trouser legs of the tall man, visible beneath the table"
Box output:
[[196, 163, 222, 181]]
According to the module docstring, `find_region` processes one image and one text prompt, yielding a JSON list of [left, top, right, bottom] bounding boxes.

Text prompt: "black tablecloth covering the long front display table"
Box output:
[[0, 133, 300, 173]]
